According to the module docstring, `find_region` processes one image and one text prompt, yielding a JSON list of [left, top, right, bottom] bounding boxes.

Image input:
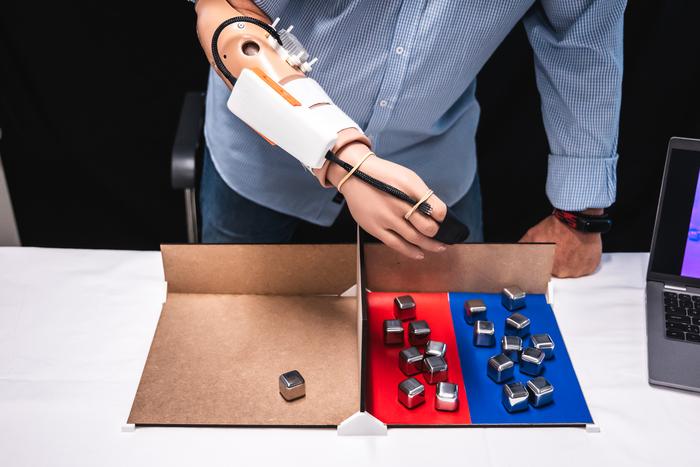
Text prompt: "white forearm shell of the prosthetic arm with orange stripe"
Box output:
[[212, 16, 362, 170]]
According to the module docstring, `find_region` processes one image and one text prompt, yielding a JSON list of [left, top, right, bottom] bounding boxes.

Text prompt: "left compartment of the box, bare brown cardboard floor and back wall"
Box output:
[[128, 245, 362, 427]]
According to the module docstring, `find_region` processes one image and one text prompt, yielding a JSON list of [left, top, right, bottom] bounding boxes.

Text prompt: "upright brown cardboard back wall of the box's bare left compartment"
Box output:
[[161, 244, 357, 295]]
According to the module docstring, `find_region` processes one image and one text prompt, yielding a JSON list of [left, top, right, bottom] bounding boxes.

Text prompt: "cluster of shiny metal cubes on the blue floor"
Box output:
[[464, 287, 554, 413]]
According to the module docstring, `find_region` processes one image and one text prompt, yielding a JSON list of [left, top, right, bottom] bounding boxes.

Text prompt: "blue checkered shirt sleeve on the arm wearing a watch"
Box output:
[[523, 0, 626, 211]]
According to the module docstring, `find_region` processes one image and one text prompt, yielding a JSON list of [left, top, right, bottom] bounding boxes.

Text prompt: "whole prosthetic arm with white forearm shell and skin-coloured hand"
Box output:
[[196, 0, 469, 258]]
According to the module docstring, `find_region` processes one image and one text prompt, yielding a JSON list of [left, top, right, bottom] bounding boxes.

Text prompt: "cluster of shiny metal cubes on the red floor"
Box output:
[[384, 295, 459, 412]]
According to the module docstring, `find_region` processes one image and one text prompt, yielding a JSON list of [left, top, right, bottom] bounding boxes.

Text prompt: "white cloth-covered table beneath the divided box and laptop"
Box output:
[[0, 248, 700, 467]]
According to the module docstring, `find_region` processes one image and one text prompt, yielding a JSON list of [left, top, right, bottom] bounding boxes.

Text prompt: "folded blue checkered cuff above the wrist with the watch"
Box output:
[[547, 154, 618, 211]]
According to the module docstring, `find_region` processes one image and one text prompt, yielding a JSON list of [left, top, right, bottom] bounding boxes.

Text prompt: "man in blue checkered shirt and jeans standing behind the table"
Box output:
[[198, 0, 626, 277]]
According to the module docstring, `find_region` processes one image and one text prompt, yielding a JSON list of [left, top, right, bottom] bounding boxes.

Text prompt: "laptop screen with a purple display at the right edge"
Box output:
[[649, 146, 700, 283]]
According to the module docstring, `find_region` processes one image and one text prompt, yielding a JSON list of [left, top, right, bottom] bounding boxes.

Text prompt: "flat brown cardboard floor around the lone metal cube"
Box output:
[[128, 296, 360, 426]]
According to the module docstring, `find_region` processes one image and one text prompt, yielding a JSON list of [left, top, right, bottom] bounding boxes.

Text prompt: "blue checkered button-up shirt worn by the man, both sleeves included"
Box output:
[[205, 0, 626, 225]]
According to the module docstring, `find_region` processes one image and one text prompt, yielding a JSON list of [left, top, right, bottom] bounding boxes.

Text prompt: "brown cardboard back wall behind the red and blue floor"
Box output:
[[364, 243, 554, 293]]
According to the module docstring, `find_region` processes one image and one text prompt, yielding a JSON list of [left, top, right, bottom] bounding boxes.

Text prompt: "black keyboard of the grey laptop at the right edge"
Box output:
[[664, 292, 700, 343]]
